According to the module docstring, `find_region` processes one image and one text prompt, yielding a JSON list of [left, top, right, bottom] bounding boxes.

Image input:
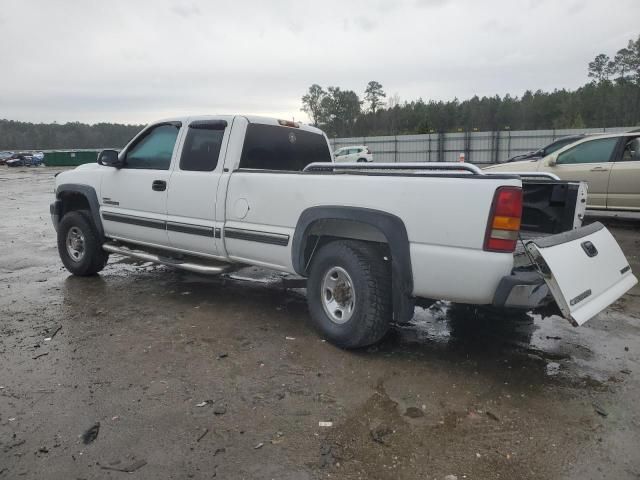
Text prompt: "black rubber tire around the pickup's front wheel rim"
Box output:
[[58, 210, 109, 276]]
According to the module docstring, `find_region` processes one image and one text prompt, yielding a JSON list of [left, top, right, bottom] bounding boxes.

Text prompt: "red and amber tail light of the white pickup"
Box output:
[[484, 187, 522, 253]]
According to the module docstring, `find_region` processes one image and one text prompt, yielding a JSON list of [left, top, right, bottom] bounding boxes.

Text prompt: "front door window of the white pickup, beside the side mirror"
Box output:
[[125, 125, 180, 170]]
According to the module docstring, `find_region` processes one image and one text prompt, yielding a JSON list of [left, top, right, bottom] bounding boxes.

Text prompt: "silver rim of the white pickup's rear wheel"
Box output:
[[320, 267, 356, 324]]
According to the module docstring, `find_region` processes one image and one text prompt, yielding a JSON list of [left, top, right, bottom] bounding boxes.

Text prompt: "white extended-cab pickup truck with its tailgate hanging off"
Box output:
[[51, 116, 637, 348]]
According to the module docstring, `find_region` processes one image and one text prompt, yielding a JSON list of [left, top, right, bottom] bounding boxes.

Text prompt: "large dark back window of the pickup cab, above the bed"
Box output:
[[240, 123, 331, 171]]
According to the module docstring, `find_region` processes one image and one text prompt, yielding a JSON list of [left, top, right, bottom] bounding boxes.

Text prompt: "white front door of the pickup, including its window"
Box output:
[[100, 122, 181, 247]]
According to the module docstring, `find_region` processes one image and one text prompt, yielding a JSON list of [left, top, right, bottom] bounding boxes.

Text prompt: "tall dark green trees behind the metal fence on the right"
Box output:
[[302, 36, 640, 137]]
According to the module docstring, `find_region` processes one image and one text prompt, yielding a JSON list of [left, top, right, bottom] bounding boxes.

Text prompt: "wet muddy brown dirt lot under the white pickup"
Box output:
[[0, 167, 640, 480]]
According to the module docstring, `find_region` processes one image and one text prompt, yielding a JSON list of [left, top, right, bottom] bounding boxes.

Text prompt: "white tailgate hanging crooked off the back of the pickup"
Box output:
[[526, 222, 638, 326]]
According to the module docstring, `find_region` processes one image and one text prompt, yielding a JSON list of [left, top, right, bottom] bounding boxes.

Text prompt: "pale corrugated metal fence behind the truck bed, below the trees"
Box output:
[[330, 127, 637, 164]]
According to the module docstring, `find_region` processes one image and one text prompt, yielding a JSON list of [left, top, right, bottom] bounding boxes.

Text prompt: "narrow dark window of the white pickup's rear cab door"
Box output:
[[180, 121, 226, 172]]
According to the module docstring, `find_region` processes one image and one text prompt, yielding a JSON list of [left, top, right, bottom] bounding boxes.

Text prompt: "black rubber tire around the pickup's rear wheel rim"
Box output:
[[307, 240, 393, 348]]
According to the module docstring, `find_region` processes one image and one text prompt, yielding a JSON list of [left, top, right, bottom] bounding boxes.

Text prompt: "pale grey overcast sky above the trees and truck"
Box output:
[[0, 0, 640, 123]]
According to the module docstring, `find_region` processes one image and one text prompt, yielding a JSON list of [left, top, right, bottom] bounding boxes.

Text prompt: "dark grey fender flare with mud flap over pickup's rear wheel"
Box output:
[[291, 206, 413, 322]]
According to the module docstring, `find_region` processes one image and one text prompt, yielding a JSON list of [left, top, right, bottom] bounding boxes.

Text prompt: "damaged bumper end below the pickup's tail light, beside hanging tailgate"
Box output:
[[493, 271, 551, 308]]
